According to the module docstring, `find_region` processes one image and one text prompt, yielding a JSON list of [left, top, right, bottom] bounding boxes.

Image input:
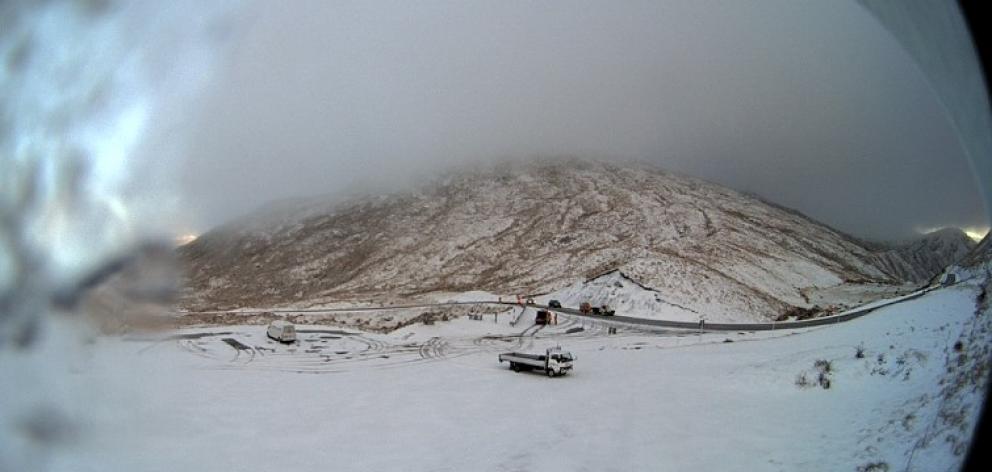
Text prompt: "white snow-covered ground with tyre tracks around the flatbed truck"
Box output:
[[49, 283, 990, 471]]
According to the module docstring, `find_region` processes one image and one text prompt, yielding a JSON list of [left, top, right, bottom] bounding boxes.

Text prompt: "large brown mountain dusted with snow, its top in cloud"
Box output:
[[180, 160, 960, 320]]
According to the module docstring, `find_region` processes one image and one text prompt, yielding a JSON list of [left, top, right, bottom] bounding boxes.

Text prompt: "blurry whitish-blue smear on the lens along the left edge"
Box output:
[[0, 0, 231, 470]]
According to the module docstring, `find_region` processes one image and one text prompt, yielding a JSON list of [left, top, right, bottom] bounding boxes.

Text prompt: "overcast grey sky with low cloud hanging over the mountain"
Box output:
[[180, 0, 987, 239]]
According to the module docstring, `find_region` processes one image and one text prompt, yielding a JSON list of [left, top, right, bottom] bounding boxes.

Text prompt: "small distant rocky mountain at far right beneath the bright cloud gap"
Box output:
[[876, 228, 975, 282]]
